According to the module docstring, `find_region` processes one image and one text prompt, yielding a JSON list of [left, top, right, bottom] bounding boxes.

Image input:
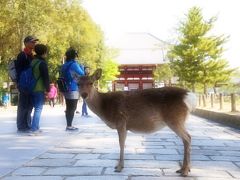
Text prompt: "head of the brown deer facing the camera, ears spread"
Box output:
[[72, 69, 102, 99]]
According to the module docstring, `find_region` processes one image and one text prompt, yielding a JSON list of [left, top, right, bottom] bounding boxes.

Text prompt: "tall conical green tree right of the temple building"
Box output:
[[169, 7, 231, 92]]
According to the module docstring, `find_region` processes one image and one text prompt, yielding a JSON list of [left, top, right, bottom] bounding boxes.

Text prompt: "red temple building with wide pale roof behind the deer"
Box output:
[[109, 33, 168, 91]]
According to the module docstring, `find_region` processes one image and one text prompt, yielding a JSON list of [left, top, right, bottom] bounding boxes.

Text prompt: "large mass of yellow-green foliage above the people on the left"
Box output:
[[0, 0, 106, 85]]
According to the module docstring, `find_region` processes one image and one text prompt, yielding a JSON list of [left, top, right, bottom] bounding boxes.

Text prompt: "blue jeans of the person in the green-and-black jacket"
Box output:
[[31, 92, 44, 131]]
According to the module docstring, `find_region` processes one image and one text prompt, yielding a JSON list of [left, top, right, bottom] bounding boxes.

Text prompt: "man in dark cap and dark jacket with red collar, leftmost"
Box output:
[[16, 36, 38, 132]]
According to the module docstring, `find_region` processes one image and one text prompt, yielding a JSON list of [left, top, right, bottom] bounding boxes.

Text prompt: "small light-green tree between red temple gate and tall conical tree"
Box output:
[[154, 64, 173, 86]]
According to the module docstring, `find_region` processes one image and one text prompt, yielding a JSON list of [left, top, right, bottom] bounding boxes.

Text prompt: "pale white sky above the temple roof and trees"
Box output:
[[82, 0, 240, 67]]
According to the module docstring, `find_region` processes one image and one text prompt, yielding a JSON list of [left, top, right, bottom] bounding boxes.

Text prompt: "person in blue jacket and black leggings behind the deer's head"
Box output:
[[61, 48, 85, 131]]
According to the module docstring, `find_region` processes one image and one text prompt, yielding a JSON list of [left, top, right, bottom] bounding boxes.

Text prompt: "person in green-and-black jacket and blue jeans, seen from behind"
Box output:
[[31, 44, 50, 134]]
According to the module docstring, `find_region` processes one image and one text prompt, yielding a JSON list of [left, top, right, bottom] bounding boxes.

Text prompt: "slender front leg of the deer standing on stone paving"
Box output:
[[115, 122, 127, 172]]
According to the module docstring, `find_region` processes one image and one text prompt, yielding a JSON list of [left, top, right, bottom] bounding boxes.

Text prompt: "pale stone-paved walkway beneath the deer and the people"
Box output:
[[0, 107, 240, 180]]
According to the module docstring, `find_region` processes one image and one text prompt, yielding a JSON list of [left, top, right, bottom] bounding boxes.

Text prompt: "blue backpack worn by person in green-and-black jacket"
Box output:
[[18, 60, 41, 93]]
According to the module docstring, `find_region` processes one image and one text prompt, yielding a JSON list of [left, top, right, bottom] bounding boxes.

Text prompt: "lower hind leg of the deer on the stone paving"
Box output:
[[169, 124, 191, 176]]
